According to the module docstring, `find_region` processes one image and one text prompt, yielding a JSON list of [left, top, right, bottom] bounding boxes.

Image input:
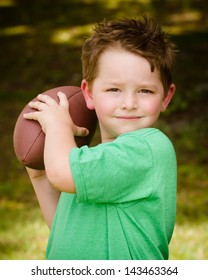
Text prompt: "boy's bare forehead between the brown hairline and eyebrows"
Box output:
[[96, 49, 162, 88]]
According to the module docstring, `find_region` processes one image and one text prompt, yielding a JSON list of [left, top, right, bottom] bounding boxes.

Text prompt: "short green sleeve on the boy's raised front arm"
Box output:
[[70, 131, 154, 203]]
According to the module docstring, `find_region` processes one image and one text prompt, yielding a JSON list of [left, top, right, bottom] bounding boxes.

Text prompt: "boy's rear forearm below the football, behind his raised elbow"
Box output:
[[26, 167, 60, 228]]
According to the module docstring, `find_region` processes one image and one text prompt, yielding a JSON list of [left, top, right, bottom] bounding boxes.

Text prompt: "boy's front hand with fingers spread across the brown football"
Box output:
[[24, 92, 89, 136]]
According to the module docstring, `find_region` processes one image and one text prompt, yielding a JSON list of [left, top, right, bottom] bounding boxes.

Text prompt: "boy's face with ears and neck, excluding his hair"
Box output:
[[82, 48, 175, 142]]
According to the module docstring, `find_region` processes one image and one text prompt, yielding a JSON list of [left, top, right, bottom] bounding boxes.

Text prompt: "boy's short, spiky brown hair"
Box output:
[[82, 16, 176, 92]]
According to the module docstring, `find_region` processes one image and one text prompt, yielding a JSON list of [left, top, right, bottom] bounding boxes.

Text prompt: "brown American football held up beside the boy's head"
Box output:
[[13, 86, 97, 170]]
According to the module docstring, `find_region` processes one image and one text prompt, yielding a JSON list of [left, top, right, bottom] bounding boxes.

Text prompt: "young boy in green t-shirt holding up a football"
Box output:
[[25, 18, 176, 260]]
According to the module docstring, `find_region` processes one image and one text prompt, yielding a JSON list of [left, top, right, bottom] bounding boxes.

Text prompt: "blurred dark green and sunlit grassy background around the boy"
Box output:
[[0, 0, 208, 260]]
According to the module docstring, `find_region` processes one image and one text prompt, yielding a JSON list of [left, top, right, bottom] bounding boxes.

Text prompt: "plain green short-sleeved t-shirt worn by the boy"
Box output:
[[47, 128, 176, 260]]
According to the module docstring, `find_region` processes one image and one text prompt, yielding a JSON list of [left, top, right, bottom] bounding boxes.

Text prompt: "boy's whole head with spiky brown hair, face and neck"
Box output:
[[81, 18, 175, 142]]
